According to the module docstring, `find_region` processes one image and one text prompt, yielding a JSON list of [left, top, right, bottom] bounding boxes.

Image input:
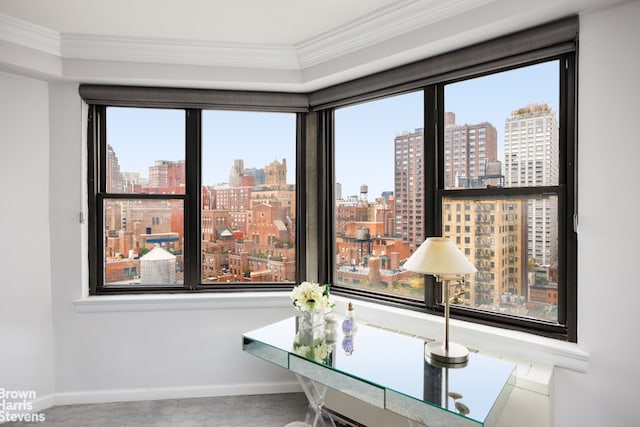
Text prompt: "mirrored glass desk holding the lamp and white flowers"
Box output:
[[242, 317, 515, 427]]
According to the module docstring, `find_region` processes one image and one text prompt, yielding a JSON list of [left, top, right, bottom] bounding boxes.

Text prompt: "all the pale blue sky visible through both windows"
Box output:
[[107, 61, 559, 196]]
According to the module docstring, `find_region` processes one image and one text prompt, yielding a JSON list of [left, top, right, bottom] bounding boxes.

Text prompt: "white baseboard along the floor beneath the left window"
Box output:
[[33, 381, 302, 412]]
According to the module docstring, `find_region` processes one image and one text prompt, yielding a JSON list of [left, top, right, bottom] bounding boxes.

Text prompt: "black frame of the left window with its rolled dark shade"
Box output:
[[84, 85, 308, 295]]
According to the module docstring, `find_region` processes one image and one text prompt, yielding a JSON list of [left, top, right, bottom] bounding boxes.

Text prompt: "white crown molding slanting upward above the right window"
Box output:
[[296, 0, 496, 69]]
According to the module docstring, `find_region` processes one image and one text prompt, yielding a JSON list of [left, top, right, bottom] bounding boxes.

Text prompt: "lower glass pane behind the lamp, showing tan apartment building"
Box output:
[[442, 195, 558, 322]]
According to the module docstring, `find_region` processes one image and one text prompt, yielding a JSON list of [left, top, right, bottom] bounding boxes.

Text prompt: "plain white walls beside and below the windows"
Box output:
[[0, 1, 640, 426]]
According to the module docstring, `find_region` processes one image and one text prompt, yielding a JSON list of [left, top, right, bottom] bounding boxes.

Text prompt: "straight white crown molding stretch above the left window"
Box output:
[[62, 34, 300, 70]]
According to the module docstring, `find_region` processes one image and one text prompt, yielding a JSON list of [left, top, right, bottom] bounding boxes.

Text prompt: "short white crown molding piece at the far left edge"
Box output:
[[0, 14, 60, 56]]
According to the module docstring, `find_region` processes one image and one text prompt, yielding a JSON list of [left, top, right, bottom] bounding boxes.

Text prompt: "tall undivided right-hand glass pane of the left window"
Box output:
[[201, 111, 296, 283]]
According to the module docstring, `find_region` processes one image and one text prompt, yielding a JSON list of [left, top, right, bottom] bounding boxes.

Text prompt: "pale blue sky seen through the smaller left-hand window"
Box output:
[[107, 107, 296, 185]]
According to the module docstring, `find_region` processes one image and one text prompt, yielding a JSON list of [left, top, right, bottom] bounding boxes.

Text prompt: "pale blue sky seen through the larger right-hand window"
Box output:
[[335, 60, 560, 200]]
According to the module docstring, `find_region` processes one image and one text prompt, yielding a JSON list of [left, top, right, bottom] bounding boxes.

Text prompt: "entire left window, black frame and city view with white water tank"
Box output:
[[81, 86, 306, 294]]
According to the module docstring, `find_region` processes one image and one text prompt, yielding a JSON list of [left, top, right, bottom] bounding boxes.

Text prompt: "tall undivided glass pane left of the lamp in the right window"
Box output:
[[335, 92, 425, 300]]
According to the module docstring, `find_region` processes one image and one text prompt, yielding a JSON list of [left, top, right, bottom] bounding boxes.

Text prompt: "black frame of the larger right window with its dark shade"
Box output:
[[310, 17, 578, 342]]
